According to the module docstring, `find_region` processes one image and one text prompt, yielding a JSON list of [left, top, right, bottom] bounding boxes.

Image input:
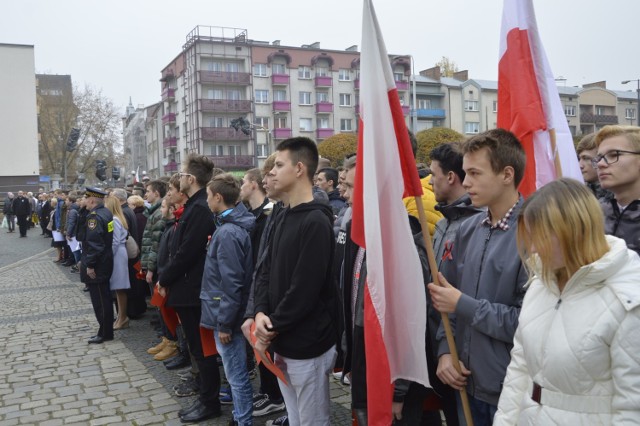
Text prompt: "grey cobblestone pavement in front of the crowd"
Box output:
[[0, 229, 351, 426]]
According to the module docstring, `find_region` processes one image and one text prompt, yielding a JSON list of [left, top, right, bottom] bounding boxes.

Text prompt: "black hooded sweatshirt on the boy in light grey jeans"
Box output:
[[254, 200, 338, 359]]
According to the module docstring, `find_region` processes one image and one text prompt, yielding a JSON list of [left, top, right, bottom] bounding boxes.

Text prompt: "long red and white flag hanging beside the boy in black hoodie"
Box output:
[[351, 0, 429, 426]]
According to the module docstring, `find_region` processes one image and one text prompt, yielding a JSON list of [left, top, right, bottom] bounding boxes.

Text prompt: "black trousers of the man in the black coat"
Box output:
[[175, 306, 220, 408]]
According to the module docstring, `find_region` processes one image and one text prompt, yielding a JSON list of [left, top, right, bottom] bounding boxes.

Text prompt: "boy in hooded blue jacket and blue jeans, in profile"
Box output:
[[200, 173, 256, 426]]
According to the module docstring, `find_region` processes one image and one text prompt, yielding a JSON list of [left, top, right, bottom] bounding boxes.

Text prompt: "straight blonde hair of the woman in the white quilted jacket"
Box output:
[[517, 178, 609, 285]]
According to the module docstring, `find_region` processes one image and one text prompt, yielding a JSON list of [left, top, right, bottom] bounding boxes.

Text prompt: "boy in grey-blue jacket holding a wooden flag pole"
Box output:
[[429, 129, 527, 426]]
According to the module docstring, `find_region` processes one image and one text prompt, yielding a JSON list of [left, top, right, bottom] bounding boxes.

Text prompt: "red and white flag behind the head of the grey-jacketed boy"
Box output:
[[497, 0, 583, 196]]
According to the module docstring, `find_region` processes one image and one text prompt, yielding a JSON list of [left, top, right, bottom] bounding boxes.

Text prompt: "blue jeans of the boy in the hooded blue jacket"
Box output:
[[213, 331, 253, 426]]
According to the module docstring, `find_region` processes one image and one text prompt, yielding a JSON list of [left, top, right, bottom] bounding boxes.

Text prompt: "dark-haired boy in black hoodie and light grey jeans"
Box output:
[[254, 137, 338, 426]]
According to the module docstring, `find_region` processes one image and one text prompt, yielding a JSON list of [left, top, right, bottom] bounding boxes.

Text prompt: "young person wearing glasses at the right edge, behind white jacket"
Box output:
[[593, 126, 640, 254]]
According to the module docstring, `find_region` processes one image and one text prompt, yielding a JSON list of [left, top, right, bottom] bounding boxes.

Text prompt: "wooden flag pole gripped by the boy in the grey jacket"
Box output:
[[415, 196, 473, 426]]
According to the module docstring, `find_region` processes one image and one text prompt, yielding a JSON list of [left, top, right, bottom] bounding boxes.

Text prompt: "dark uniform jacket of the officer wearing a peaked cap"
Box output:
[[79, 205, 113, 284]]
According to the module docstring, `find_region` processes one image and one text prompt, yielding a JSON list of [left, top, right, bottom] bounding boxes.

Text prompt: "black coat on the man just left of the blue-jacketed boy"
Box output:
[[160, 188, 215, 307]]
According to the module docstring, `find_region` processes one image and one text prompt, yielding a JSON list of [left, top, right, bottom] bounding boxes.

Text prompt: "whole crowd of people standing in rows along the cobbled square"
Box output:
[[40, 121, 640, 426]]
